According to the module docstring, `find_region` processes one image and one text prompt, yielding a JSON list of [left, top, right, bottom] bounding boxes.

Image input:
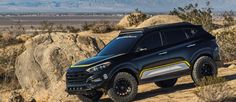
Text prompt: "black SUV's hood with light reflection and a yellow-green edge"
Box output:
[[71, 54, 124, 68]]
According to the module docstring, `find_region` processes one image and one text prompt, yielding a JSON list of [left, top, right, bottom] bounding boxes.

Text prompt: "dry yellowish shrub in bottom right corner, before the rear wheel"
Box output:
[[194, 77, 235, 102]]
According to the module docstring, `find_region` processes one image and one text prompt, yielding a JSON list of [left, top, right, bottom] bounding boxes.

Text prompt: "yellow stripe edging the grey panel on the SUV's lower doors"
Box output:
[[139, 61, 191, 78]]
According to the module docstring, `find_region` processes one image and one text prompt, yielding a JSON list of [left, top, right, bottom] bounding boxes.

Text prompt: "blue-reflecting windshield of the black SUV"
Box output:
[[98, 34, 141, 56]]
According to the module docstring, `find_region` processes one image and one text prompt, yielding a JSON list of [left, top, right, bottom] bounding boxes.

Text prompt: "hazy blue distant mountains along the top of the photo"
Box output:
[[0, 0, 236, 12]]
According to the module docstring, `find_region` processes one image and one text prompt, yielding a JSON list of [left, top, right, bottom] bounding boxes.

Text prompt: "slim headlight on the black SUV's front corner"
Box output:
[[86, 62, 111, 73]]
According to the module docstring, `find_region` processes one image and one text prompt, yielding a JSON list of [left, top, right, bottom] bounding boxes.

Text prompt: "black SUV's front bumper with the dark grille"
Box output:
[[66, 70, 108, 95]]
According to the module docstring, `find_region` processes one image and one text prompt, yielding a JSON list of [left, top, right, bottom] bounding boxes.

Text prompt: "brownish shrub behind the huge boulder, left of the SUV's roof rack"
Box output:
[[91, 22, 114, 33]]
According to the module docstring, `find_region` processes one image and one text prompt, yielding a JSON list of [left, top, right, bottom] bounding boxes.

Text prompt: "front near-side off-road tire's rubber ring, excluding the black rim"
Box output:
[[108, 72, 138, 102]]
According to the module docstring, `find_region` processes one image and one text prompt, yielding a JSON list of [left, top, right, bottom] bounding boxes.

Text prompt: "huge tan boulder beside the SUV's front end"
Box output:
[[15, 34, 104, 101]]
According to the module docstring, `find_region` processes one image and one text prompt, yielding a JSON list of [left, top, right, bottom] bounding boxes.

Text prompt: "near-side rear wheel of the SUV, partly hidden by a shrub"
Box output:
[[192, 56, 218, 85]]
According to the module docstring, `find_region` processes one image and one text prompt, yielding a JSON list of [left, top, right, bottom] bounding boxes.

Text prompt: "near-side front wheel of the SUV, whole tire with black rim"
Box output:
[[108, 72, 138, 102]]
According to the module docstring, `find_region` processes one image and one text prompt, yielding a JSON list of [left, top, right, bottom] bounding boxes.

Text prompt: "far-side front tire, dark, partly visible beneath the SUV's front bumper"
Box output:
[[77, 91, 103, 102]]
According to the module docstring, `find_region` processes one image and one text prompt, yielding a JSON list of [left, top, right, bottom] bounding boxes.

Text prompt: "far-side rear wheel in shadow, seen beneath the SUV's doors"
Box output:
[[155, 78, 178, 88]]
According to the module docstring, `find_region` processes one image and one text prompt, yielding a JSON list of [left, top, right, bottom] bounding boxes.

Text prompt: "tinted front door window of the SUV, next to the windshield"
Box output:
[[136, 32, 162, 51]]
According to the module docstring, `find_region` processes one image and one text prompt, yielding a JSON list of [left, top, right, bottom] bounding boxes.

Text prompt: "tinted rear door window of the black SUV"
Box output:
[[161, 29, 187, 45]]
